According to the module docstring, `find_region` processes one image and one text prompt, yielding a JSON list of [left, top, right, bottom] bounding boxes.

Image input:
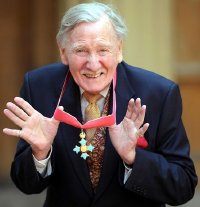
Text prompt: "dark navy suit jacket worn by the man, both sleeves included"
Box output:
[[11, 62, 197, 207]]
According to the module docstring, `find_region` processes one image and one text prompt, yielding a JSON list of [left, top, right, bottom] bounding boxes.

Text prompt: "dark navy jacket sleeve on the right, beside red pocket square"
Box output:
[[125, 84, 197, 205]]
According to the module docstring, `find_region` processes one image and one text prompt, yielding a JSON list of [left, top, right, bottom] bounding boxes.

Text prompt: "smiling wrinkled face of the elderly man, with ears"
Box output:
[[60, 18, 122, 94]]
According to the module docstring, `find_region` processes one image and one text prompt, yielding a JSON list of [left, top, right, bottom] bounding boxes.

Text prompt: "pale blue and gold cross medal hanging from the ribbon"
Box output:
[[73, 130, 94, 160]]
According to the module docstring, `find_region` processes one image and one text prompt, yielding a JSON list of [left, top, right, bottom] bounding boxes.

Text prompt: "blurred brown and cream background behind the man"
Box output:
[[0, 0, 200, 207]]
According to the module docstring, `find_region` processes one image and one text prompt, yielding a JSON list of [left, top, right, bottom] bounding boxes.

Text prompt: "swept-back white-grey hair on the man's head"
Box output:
[[56, 2, 127, 47]]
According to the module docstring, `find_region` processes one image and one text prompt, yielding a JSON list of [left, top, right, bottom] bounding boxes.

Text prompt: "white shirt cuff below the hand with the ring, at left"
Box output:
[[32, 146, 52, 177]]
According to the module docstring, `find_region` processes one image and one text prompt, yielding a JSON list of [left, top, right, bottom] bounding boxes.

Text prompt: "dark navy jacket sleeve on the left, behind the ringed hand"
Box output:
[[11, 73, 54, 194]]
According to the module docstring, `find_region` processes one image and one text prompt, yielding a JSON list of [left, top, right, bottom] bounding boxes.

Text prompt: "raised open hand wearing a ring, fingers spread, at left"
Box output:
[[3, 97, 59, 160]]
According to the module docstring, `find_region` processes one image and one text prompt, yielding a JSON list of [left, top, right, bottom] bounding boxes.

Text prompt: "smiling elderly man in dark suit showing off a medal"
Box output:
[[3, 3, 197, 207]]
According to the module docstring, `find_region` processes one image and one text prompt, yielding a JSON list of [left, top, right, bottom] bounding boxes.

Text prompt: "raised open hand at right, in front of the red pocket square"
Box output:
[[108, 98, 149, 164]]
